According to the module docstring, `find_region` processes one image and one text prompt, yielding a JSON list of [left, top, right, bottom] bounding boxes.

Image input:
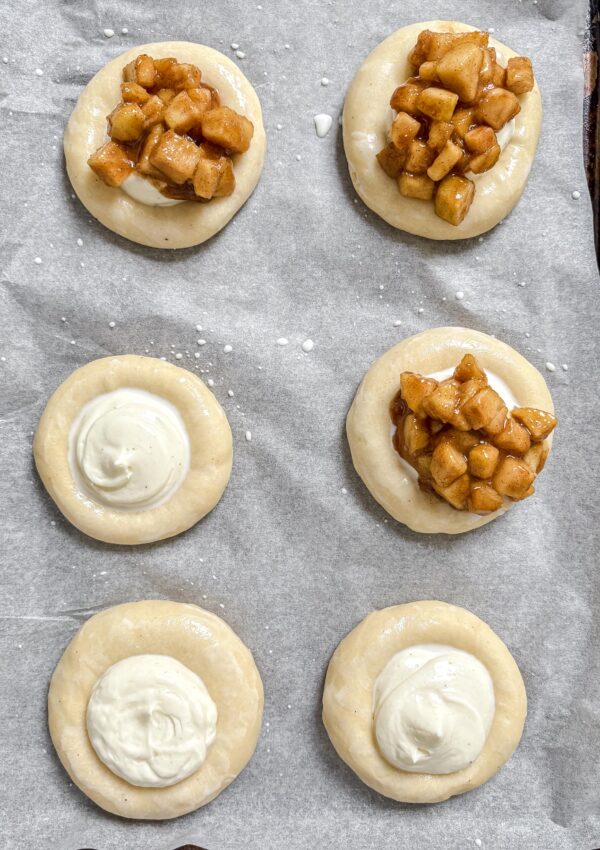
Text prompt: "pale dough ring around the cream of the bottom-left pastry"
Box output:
[[48, 601, 263, 820]]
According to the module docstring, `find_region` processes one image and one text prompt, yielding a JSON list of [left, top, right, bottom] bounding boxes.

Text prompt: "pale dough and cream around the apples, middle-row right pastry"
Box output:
[[346, 328, 554, 534]]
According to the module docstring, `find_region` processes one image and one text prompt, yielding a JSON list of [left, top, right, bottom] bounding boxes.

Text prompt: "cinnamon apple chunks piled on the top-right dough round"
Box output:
[[377, 30, 534, 225]]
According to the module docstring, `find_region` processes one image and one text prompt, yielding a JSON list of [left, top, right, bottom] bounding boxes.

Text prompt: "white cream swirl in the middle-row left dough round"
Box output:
[[68, 387, 190, 510]]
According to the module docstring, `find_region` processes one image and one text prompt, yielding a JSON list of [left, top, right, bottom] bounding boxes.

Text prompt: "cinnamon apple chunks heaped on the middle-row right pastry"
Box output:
[[390, 354, 556, 514]]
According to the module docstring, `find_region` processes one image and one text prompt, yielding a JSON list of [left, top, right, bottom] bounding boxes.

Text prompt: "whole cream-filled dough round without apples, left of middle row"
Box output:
[[33, 355, 233, 545]]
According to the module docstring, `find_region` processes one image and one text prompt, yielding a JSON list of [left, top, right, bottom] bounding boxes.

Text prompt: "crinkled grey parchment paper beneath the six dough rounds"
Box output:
[[0, 0, 600, 850]]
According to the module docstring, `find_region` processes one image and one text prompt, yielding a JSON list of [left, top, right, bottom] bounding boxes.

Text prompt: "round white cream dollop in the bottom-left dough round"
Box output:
[[87, 655, 217, 788]]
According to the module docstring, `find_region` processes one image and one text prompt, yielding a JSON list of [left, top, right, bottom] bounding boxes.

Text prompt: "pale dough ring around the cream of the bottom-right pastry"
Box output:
[[323, 601, 527, 803]]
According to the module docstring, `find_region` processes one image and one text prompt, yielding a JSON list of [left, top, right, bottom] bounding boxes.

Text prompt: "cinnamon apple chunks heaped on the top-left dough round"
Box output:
[[88, 54, 254, 201]]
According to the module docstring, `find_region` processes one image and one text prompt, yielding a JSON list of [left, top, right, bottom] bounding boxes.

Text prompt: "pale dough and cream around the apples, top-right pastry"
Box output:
[[343, 21, 542, 239]]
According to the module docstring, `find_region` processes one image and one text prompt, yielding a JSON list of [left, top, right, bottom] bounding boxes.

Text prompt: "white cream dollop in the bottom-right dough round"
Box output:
[[373, 644, 495, 774]]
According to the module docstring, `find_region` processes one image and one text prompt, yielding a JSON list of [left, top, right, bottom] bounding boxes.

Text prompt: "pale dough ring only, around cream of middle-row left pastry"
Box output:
[[33, 355, 233, 545]]
